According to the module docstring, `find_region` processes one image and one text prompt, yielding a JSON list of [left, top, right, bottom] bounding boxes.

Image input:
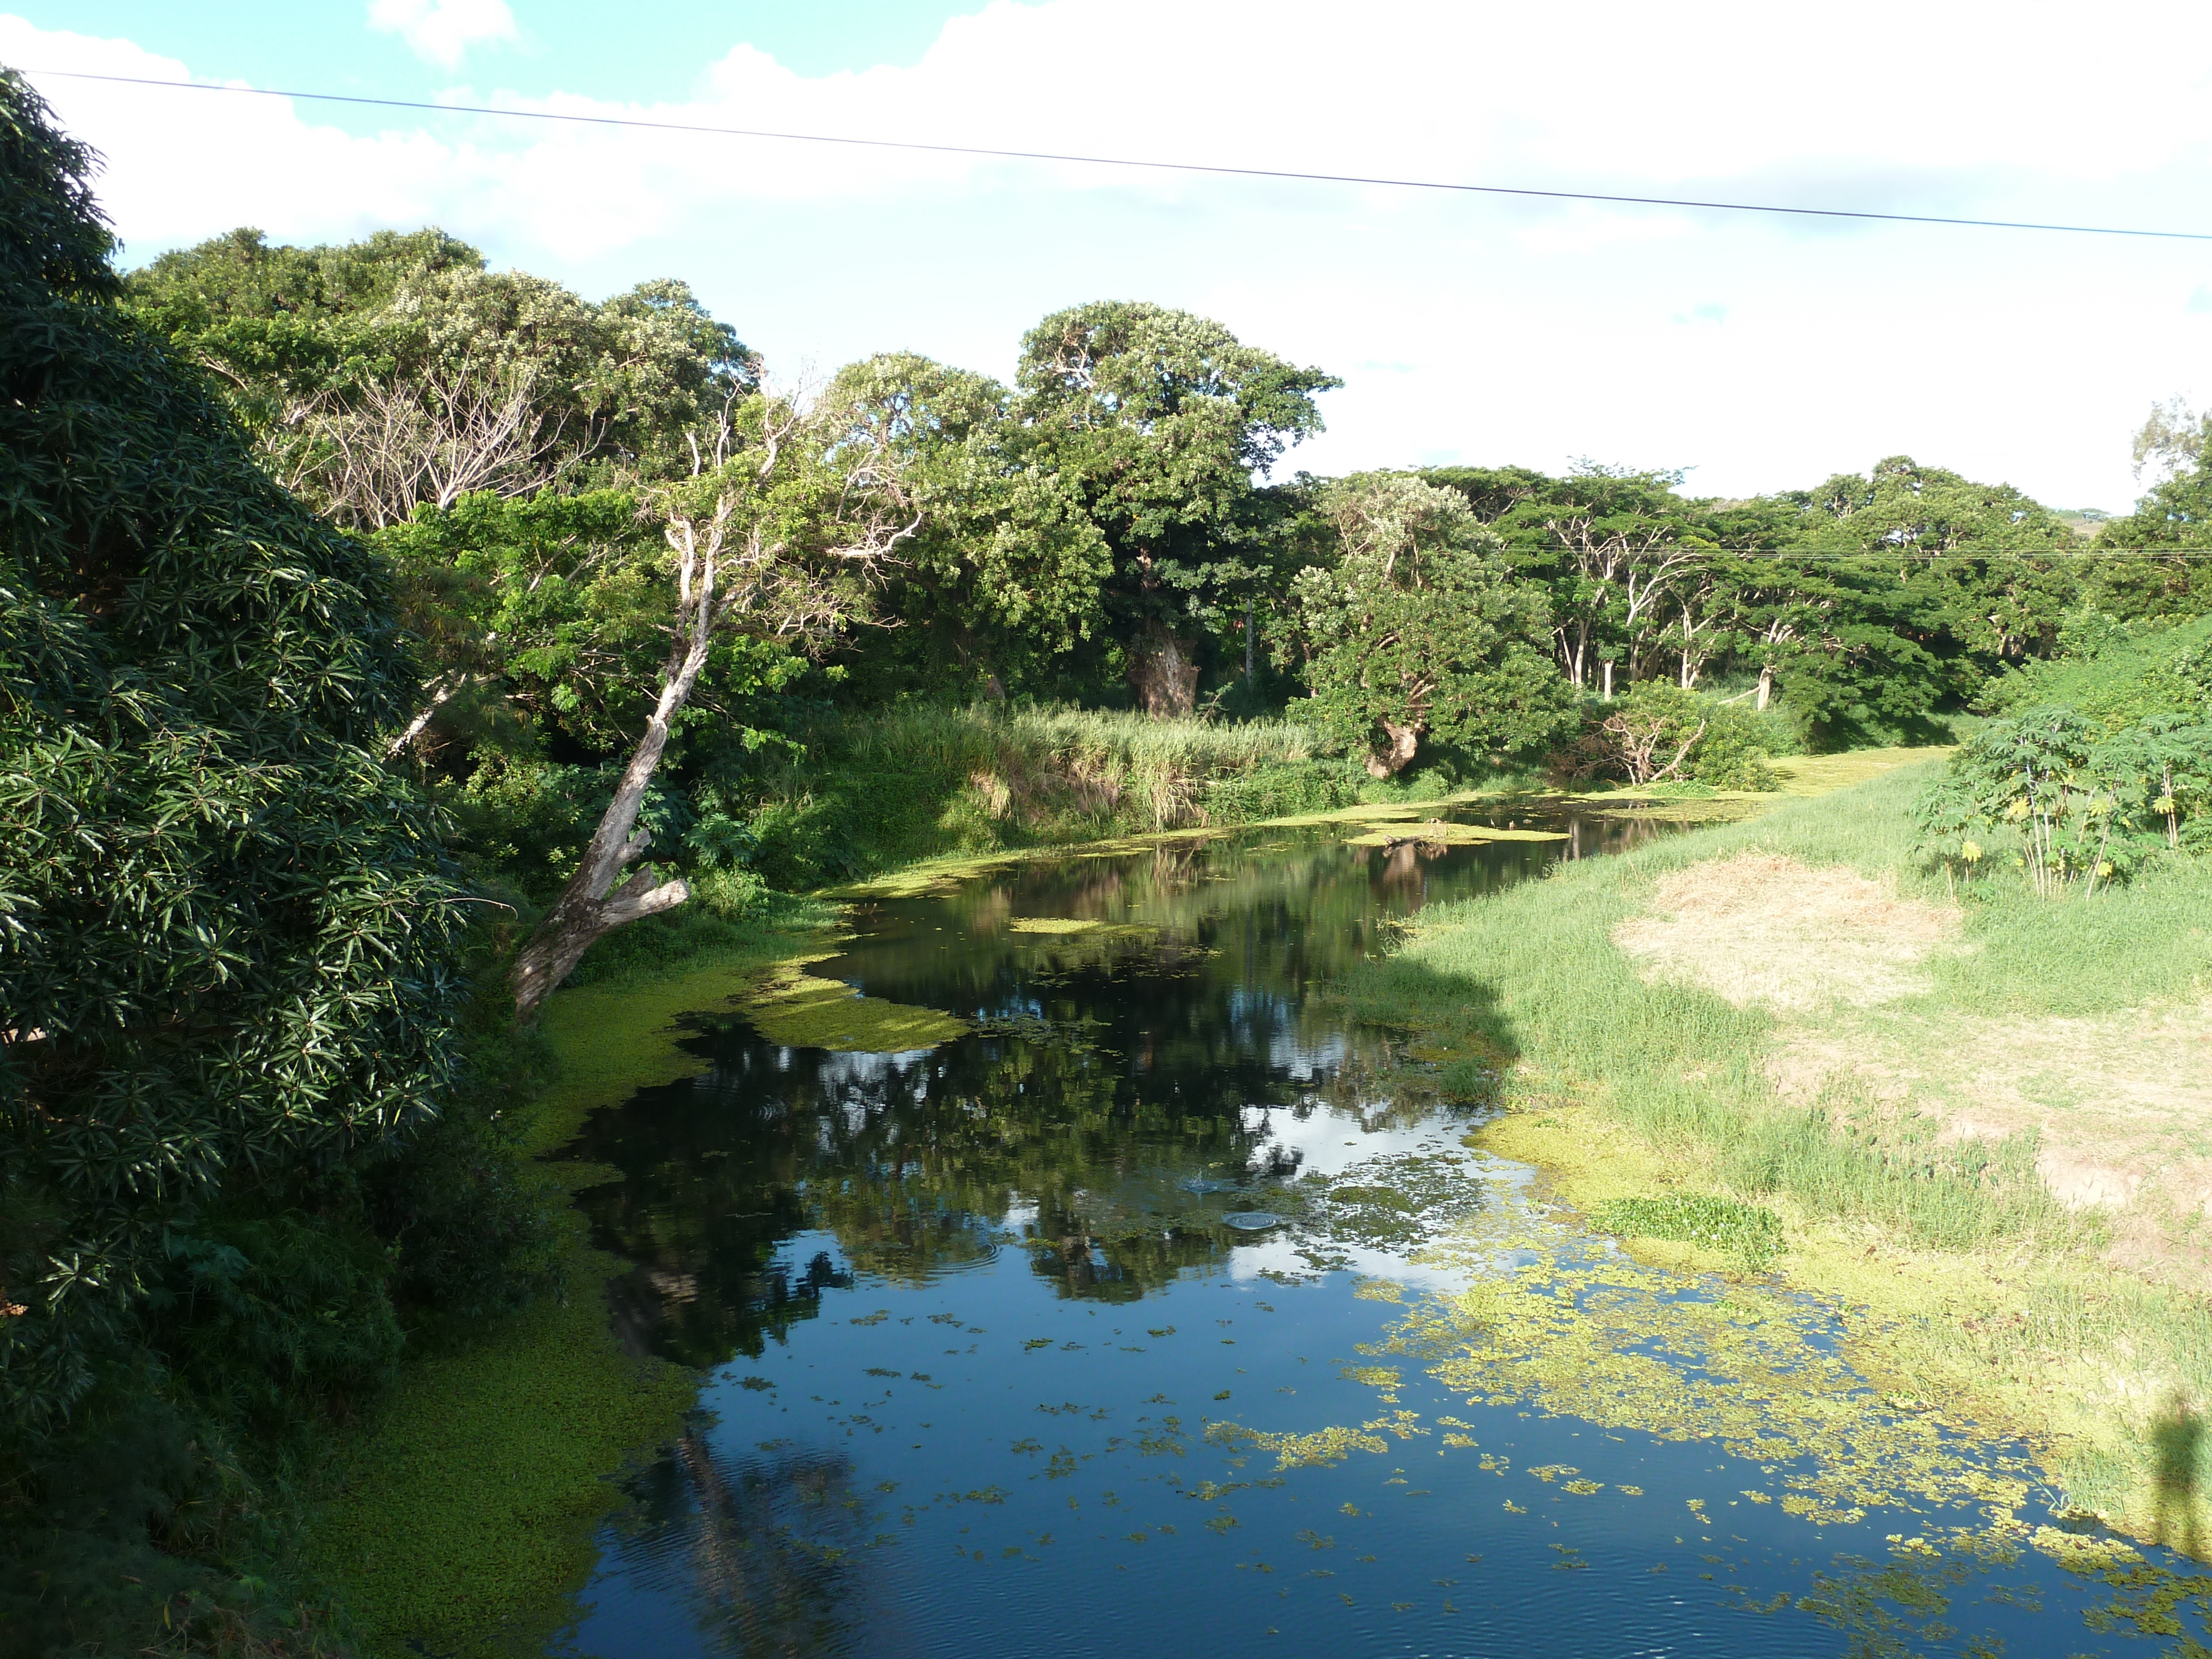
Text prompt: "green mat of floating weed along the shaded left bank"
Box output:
[[307, 900, 834, 1659]]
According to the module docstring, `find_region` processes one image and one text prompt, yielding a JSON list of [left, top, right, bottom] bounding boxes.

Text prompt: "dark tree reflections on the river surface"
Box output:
[[549, 805, 1725, 1655]]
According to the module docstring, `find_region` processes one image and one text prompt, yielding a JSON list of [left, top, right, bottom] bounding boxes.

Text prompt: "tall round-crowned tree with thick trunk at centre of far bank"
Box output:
[[1013, 301, 1340, 714]]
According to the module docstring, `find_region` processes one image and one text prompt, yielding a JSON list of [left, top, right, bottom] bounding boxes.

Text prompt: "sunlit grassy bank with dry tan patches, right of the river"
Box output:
[[1347, 765, 2212, 1548]]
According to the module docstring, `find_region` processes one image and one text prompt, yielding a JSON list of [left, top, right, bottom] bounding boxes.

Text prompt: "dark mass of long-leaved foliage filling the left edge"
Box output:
[[0, 71, 562, 1655]]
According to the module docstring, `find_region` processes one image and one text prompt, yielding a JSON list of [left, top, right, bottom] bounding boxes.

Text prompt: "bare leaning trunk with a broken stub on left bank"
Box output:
[[511, 637, 706, 1026]]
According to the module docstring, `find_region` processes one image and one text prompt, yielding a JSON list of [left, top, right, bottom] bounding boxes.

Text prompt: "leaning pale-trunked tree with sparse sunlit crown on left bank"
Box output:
[[511, 394, 920, 1022]]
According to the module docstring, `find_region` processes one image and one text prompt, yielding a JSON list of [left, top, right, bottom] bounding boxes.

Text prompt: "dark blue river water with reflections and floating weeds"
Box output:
[[553, 821, 2205, 1659]]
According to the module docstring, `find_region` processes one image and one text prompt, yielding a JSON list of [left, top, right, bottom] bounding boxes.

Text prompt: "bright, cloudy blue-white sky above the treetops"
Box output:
[[0, 0, 2212, 511]]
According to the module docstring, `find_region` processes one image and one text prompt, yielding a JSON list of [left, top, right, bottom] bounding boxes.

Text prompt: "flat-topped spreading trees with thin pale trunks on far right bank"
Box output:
[[1422, 456, 2095, 750]]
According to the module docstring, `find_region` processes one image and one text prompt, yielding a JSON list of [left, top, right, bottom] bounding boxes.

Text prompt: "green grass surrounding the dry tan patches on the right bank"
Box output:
[[1347, 752, 2212, 1537]]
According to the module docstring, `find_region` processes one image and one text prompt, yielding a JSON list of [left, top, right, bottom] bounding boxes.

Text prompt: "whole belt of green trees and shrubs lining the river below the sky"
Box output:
[[13, 61, 2212, 1655]]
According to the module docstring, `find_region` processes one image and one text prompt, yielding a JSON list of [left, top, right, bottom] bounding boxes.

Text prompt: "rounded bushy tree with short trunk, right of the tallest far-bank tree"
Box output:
[[1294, 473, 1575, 779]]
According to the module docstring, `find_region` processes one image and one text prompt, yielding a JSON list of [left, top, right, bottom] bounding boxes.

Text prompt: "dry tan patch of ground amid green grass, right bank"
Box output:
[[1613, 849, 2212, 1281]]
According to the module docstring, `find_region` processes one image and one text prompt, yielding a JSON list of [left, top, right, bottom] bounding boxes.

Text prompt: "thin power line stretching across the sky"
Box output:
[[22, 69, 2212, 241]]
